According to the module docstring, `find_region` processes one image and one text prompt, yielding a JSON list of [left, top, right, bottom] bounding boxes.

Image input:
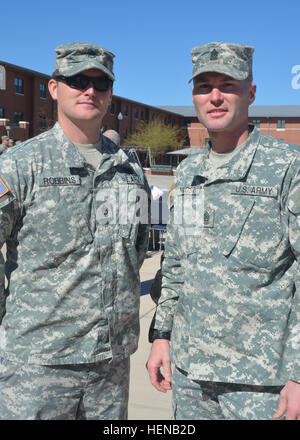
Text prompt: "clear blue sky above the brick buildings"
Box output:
[[0, 0, 300, 106]]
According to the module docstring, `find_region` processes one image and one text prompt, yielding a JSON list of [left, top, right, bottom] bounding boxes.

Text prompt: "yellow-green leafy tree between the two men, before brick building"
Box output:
[[126, 120, 185, 163]]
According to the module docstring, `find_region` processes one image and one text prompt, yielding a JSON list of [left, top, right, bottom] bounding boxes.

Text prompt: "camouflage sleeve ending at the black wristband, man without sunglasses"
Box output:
[[149, 190, 183, 342]]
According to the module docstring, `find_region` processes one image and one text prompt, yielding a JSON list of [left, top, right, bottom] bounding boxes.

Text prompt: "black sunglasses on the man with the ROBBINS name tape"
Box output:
[[53, 73, 113, 92]]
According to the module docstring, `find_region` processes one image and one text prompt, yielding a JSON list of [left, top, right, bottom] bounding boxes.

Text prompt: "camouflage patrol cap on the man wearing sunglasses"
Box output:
[[55, 43, 115, 81]]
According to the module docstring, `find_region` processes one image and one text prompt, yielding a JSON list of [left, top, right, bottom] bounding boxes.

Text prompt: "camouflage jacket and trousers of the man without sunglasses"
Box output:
[[150, 43, 300, 419]]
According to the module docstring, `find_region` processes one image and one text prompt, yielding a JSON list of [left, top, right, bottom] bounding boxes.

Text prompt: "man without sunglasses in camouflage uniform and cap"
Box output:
[[148, 43, 300, 420]]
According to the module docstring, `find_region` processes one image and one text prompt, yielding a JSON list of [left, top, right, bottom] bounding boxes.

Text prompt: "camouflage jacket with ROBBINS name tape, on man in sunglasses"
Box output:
[[0, 124, 148, 418]]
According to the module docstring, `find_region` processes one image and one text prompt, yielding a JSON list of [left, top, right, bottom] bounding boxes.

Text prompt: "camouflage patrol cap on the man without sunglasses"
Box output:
[[189, 42, 254, 82]]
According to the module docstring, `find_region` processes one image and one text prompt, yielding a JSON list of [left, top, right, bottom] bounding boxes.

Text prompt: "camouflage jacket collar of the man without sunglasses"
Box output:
[[189, 127, 260, 183]]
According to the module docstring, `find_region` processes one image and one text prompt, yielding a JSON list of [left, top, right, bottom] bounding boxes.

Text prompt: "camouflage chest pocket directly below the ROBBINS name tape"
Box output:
[[24, 181, 93, 267]]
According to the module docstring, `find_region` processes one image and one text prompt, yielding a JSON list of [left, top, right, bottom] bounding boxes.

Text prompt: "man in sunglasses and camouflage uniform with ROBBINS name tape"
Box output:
[[0, 43, 150, 419]]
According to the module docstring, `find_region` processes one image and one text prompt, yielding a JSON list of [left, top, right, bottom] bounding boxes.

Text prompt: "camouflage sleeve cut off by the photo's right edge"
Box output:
[[286, 163, 300, 382]]
